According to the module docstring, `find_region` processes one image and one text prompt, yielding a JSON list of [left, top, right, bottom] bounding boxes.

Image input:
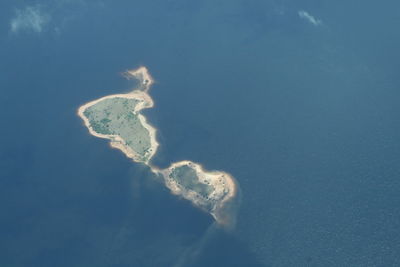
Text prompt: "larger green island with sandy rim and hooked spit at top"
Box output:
[[78, 67, 158, 164]]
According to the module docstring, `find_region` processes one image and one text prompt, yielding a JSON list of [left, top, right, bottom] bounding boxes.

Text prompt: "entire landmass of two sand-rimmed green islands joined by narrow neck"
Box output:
[[78, 66, 239, 228]]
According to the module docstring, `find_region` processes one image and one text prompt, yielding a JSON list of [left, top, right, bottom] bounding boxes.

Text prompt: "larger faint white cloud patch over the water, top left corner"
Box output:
[[10, 5, 50, 33]]
